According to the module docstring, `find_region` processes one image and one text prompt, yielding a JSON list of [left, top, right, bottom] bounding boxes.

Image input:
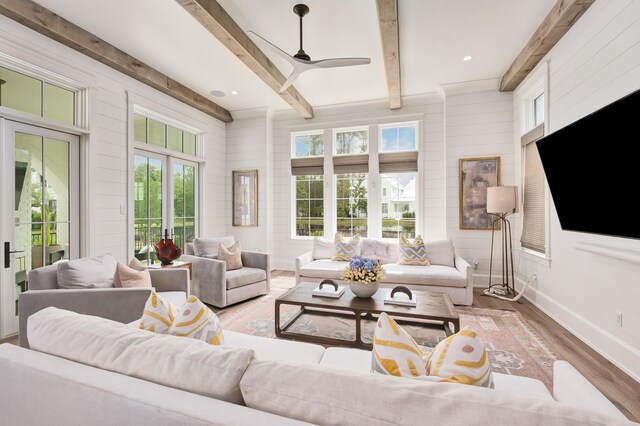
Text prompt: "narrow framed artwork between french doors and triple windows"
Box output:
[[231, 170, 258, 226]]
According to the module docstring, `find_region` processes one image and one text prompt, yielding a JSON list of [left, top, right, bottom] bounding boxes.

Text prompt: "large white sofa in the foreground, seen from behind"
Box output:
[[0, 308, 630, 426]]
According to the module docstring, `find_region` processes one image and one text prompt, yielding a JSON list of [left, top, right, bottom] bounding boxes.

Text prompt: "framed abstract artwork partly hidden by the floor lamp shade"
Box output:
[[460, 157, 500, 230]]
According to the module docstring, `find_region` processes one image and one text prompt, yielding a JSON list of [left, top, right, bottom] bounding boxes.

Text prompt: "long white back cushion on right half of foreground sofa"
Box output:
[[240, 360, 626, 426]]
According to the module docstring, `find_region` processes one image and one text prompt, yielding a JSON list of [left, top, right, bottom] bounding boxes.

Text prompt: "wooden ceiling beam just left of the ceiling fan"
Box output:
[[176, 0, 313, 118]]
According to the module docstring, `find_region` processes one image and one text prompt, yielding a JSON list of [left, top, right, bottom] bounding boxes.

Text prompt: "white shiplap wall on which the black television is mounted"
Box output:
[[514, 0, 640, 381]]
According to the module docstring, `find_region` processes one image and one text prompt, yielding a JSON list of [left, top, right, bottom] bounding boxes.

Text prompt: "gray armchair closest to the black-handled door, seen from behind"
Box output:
[[18, 265, 190, 348]]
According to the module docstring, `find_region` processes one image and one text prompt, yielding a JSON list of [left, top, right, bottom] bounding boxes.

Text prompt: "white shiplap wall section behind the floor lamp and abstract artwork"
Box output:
[[443, 80, 515, 286]]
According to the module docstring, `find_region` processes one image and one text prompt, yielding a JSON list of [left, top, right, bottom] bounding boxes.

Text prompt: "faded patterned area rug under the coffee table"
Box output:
[[217, 277, 557, 390]]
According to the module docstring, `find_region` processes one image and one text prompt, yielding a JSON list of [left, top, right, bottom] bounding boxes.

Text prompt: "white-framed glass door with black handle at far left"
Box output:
[[0, 117, 80, 338]]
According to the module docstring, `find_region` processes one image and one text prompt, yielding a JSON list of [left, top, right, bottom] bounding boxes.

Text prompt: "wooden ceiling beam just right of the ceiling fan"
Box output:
[[376, 0, 402, 109]]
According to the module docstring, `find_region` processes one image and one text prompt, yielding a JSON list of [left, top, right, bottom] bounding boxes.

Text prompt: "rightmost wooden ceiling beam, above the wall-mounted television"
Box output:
[[500, 0, 596, 92]]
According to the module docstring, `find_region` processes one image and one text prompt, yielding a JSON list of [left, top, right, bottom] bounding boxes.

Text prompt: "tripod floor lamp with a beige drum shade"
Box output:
[[487, 186, 516, 295]]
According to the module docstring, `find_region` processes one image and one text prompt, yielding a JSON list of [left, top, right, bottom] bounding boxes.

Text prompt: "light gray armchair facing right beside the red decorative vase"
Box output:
[[180, 237, 271, 308]]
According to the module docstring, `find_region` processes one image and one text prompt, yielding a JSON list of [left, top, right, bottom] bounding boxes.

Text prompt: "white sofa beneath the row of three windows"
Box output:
[[296, 237, 473, 306]]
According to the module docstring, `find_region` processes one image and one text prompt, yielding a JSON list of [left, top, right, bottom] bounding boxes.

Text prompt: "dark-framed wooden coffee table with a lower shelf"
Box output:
[[275, 283, 460, 349]]
